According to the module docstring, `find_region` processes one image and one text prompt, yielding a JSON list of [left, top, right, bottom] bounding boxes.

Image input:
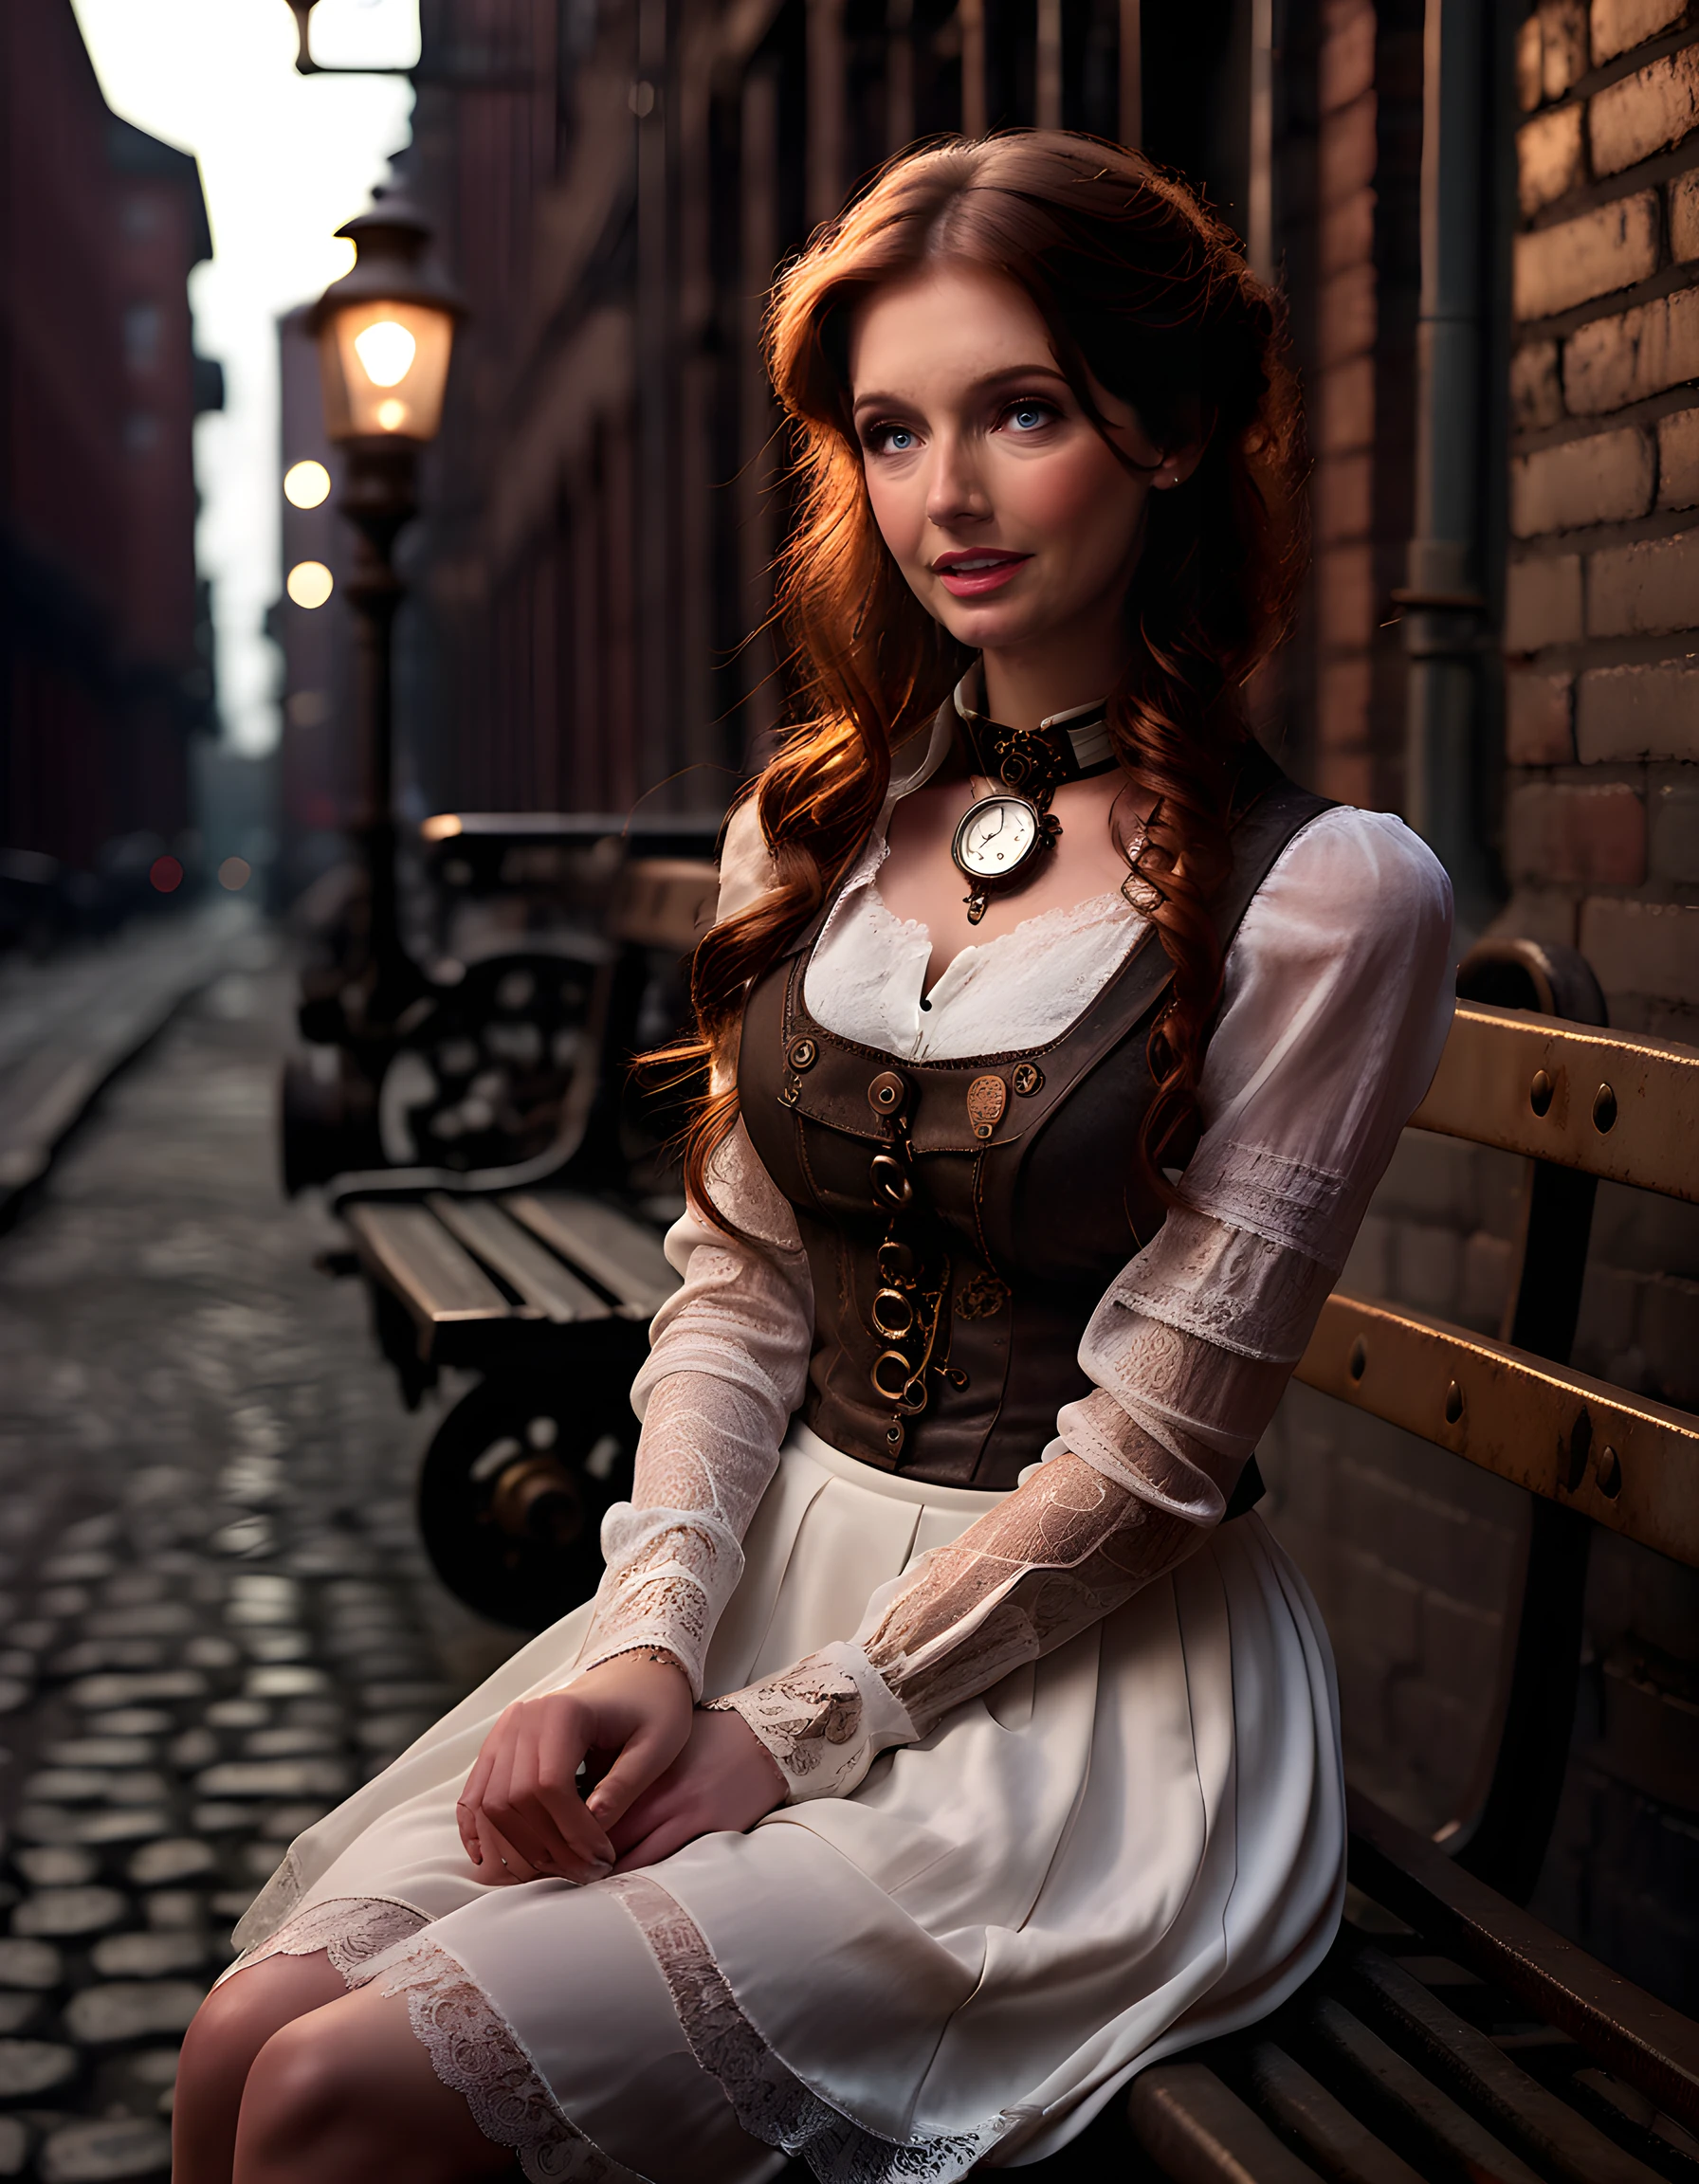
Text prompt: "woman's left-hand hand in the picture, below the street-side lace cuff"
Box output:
[[454, 1653, 689, 1883]]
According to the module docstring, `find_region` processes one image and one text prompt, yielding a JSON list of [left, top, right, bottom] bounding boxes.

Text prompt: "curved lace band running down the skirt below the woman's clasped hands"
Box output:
[[603, 1874, 1014, 2184]]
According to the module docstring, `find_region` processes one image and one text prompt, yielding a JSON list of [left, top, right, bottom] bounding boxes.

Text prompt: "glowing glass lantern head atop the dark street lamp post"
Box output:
[[315, 196, 466, 441]]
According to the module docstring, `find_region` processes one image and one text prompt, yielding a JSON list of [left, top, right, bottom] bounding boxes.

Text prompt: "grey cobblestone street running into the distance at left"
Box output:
[[0, 935, 516, 2184]]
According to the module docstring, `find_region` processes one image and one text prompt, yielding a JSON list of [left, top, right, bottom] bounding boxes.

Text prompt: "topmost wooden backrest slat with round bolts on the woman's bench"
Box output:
[[1411, 1000, 1699, 1201]]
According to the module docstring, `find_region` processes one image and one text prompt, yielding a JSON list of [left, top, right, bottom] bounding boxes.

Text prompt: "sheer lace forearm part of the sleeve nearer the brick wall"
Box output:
[[710, 1454, 1205, 1804]]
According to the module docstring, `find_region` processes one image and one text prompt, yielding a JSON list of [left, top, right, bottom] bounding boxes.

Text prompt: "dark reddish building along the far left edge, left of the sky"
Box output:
[[0, 0, 223, 921]]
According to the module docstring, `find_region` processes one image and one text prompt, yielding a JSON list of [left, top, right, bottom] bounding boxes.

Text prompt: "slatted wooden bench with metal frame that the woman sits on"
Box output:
[[1105, 941, 1699, 2184]]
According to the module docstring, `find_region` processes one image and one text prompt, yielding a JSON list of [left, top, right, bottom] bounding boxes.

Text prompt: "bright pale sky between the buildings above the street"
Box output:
[[73, 0, 419, 752]]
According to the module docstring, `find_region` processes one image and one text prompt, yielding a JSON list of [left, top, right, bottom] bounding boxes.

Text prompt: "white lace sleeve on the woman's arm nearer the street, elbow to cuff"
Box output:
[[575, 1125, 814, 1695]]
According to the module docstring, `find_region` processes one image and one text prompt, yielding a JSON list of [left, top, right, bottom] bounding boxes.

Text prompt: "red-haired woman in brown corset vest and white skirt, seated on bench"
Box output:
[[177, 134, 1450, 2184]]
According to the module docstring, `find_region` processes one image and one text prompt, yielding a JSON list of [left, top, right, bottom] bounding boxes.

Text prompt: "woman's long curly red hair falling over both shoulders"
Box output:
[[650, 131, 1304, 1206]]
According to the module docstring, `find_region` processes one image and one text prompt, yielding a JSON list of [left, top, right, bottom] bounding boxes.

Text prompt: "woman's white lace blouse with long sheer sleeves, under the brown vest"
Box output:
[[576, 749, 1450, 1797]]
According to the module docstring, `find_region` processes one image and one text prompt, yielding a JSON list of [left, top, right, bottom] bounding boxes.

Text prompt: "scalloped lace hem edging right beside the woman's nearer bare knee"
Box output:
[[350, 1933, 631, 2184]]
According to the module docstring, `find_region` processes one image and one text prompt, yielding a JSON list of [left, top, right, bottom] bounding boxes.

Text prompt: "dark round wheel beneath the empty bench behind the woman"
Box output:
[[419, 1371, 638, 1631]]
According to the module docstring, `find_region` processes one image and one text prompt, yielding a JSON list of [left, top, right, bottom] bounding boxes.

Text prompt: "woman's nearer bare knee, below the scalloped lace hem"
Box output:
[[228, 1988, 513, 2184]]
